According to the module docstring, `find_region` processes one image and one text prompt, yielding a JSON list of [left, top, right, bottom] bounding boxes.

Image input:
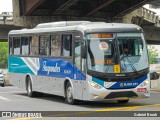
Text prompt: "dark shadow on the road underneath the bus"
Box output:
[[15, 93, 150, 108]]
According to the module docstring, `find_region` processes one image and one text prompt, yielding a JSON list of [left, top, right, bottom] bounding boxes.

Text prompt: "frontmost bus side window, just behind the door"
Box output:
[[62, 34, 72, 57]]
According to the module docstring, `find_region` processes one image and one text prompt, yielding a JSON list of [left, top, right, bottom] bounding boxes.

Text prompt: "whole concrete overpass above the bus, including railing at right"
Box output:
[[1, 0, 160, 43]]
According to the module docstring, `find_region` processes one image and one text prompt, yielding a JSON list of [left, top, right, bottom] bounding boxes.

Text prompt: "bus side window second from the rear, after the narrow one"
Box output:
[[13, 37, 20, 55]]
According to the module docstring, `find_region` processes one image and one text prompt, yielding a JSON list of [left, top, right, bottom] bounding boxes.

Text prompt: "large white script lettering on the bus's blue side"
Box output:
[[42, 61, 60, 75]]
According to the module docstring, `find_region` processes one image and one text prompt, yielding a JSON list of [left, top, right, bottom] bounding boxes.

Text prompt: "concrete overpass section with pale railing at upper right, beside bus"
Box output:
[[122, 7, 160, 44]]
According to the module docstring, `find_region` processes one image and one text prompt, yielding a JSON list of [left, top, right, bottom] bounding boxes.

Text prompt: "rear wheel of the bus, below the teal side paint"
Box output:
[[27, 77, 36, 97]]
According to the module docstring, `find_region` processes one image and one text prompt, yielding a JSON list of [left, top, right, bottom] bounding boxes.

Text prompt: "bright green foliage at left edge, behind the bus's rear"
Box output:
[[0, 42, 8, 68]]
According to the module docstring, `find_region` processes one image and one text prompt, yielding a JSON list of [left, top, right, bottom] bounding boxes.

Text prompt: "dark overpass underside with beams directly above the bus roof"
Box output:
[[12, 0, 153, 28]]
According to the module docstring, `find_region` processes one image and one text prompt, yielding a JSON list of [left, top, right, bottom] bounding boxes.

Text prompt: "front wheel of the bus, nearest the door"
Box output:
[[65, 82, 77, 105]]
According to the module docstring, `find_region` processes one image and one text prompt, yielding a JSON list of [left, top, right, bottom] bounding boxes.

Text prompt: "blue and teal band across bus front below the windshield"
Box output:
[[92, 76, 147, 89]]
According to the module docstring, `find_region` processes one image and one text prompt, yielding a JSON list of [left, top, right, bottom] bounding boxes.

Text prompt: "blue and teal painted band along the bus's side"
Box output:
[[9, 56, 86, 80]]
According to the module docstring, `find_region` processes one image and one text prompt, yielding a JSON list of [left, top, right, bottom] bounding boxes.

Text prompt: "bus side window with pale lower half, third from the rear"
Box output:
[[21, 36, 29, 55]]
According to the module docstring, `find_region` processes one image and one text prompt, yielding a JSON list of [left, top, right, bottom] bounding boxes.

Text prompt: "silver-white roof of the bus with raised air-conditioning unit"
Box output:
[[9, 21, 142, 35]]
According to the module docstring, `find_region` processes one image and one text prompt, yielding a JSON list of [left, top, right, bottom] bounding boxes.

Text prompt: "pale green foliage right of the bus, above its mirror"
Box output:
[[148, 48, 158, 64]]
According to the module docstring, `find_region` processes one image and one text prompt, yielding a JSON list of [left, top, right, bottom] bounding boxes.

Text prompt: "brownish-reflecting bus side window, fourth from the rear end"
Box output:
[[30, 36, 39, 55]]
